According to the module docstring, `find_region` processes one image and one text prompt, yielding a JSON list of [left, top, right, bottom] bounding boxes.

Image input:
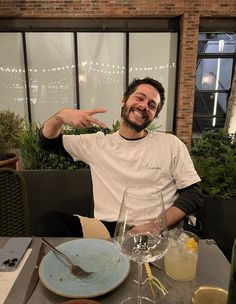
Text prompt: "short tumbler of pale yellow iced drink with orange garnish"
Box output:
[[164, 228, 199, 281]]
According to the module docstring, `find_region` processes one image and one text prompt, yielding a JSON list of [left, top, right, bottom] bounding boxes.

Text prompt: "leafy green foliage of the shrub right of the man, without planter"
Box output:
[[191, 129, 236, 198]]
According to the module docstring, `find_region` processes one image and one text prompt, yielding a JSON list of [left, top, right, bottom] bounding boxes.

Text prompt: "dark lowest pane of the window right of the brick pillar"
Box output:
[[193, 92, 227, 133]]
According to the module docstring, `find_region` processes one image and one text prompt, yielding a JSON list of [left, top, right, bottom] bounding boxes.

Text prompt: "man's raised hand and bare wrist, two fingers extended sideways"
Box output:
[[43, 108, 108, 138]]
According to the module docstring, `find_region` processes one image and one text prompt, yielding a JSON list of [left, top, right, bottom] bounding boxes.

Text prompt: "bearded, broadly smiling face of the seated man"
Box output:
[[122, 84, 161, 132]]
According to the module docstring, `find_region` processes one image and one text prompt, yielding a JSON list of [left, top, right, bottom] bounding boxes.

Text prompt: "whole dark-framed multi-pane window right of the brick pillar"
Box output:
[[193, 33, 236, 136]]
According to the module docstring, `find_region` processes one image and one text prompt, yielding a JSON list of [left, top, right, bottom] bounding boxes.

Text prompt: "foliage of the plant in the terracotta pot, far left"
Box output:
[[0, 110, 25, 160]]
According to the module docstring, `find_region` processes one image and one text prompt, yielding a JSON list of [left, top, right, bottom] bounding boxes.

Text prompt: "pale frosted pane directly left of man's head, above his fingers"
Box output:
[[78, 33, 125, 127]]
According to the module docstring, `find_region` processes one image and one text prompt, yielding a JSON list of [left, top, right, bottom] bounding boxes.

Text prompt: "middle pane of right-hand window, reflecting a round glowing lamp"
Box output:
[[196, 58, 233, 90]]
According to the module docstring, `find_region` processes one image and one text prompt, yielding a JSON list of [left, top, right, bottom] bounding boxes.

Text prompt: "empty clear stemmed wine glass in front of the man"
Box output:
[[114, 186, 168, 304]]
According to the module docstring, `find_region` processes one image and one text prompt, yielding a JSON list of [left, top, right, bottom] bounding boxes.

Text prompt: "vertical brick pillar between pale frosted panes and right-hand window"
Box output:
[[176, 13, 200, 146]]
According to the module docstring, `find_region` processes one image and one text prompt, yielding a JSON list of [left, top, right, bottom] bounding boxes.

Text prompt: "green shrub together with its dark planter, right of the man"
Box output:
[[190, 129, 236, 261]]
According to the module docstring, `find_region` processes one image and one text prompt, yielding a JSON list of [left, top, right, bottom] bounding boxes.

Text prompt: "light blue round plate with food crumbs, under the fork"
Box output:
[[39, 239, 130, 298]]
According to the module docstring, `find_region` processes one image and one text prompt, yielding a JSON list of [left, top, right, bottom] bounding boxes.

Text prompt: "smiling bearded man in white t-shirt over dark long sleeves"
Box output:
[[38, 77, 202, 236]]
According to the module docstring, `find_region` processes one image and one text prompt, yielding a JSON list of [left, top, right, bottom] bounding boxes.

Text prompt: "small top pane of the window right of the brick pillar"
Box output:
[[198, 33, 236, 53]]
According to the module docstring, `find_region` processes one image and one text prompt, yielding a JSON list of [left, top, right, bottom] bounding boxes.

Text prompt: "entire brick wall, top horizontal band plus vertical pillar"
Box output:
[[0, 0, 236, 147]]
